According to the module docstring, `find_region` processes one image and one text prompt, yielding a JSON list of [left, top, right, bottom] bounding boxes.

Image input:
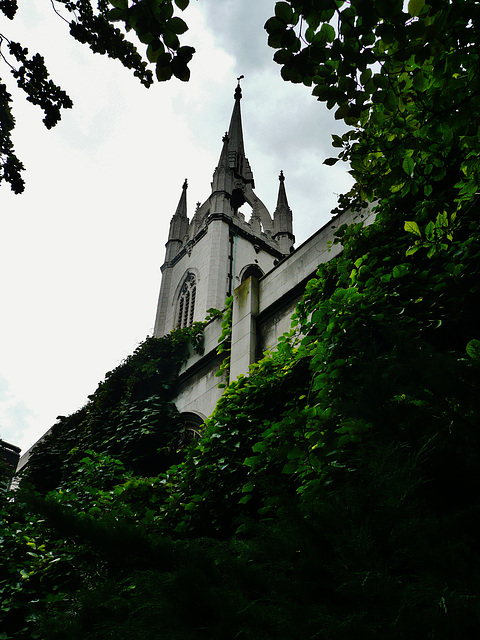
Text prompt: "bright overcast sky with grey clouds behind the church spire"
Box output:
[[0, 0, 351, 451]]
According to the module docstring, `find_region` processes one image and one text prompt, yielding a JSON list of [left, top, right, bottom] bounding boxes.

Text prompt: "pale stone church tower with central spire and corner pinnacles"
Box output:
[[154, 80, 295, 337]]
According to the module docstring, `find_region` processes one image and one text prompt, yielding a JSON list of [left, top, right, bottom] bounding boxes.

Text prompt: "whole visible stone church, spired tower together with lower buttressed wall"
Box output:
[[154, 84, 373, 424]]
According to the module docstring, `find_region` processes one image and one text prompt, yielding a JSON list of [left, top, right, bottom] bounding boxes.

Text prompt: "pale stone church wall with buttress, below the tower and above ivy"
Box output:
[[175, 209, 374, 416]]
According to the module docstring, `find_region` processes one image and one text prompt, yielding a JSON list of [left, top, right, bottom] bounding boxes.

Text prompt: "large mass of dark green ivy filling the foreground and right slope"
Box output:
[[6, 207, 480, 640]]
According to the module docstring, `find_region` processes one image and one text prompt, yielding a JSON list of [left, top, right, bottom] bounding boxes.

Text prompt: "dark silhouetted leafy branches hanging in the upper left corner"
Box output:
[[0, 0, 194, 193]]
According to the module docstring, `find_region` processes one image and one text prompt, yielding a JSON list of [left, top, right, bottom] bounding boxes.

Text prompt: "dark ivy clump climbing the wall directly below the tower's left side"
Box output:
[[22, 322, 204, 492]]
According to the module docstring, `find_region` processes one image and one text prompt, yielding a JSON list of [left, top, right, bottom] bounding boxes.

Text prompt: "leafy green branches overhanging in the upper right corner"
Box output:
[[265, 0, 480, 235]]
